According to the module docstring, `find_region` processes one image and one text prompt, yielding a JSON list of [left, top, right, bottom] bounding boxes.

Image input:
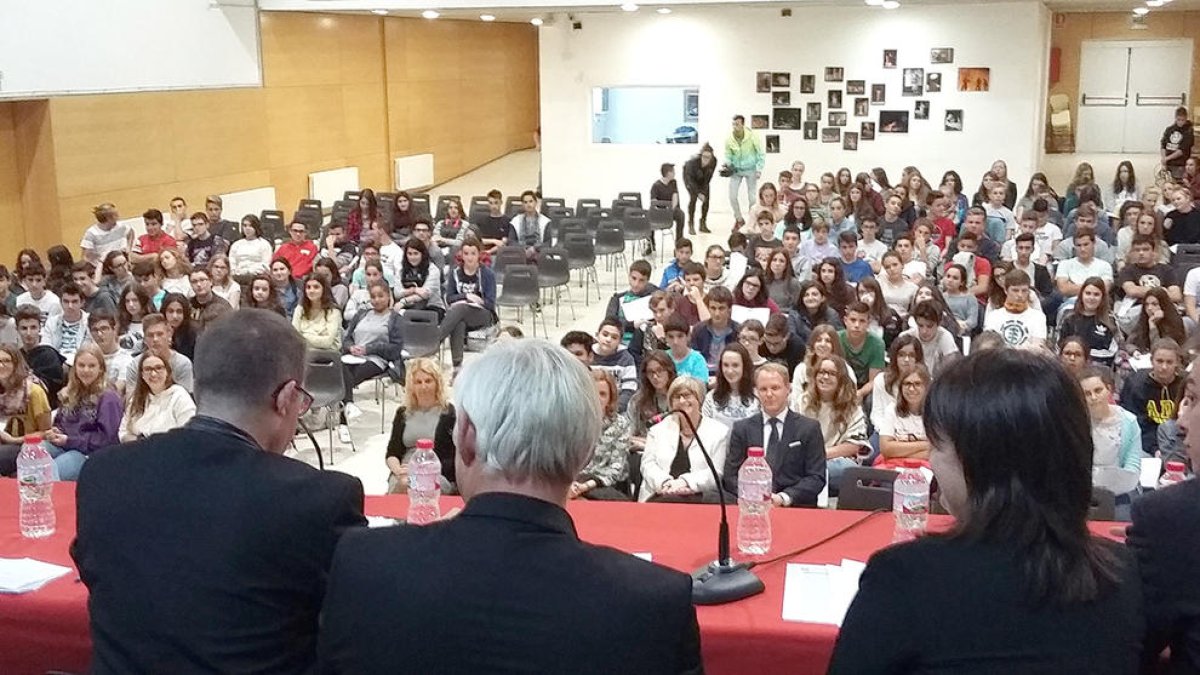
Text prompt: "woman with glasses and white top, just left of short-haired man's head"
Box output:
[[120, 353, 196, 443]]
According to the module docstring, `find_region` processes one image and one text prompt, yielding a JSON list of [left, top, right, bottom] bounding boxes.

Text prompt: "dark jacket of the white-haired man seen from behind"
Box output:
[[318, 492, 702, 675]]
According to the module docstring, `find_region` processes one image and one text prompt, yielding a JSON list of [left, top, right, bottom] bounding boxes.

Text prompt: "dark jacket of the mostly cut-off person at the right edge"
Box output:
[[1127, 480, 1200, 673]]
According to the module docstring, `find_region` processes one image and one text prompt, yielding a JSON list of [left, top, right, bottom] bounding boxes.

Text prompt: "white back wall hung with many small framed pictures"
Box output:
[[540, 1, 1050, 210]]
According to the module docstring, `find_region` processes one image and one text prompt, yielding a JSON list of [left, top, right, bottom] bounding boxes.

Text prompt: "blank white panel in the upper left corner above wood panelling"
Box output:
[[0, 0, 263, 98]]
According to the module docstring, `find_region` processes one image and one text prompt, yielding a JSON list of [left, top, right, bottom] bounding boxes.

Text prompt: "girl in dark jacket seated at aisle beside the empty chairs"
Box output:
[[440, 237, 497, 375]]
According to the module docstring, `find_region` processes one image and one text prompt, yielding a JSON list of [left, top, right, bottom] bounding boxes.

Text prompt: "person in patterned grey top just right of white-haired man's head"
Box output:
[[568, 370, 630, 502]]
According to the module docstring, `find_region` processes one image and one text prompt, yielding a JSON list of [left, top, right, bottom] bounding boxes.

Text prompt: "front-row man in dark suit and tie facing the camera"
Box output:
[[721, 363, 826, 507]]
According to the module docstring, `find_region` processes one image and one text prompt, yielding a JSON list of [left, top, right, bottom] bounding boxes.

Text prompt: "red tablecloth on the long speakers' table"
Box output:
[[0, 479, 1110, 675]]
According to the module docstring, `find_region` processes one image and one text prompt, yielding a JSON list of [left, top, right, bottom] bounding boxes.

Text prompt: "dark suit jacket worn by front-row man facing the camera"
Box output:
[[721, 411, 826, 506]]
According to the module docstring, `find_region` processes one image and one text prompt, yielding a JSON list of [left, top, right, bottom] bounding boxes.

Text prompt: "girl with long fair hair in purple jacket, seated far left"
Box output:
[[46, 342, 125, 480]]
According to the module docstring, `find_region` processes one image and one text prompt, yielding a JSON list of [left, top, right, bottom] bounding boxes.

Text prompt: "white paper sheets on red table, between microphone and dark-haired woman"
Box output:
[[782, 560, 866, 626]]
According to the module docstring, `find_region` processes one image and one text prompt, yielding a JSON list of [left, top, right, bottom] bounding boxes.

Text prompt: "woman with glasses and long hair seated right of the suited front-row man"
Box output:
[[799, 353, 870, 495]]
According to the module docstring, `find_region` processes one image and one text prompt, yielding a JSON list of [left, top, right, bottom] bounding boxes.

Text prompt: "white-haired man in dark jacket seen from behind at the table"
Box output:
[[318, 340, 702, 675]]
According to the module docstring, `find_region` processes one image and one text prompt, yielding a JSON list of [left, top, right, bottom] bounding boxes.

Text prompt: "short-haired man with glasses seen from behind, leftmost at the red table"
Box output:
[[72, 310, 366, 674]]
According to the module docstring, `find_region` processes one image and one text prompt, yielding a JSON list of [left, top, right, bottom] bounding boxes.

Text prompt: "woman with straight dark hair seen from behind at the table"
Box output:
[[829, 350, 1144, 675]]
